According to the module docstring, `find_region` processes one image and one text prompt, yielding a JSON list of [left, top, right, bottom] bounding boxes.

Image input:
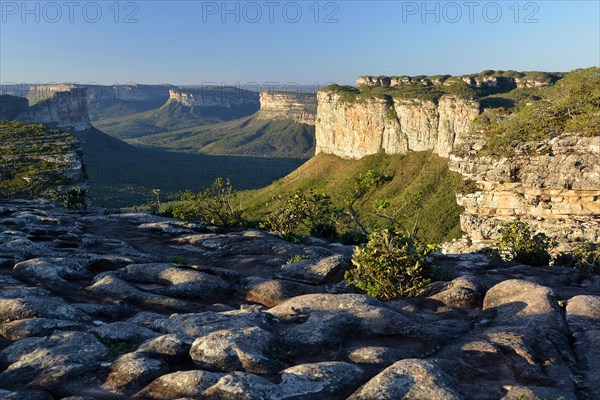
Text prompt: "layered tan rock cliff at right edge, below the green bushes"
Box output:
[[449, 135, 600, 247]]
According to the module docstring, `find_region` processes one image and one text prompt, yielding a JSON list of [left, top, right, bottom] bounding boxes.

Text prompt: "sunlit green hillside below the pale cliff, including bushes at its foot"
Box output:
[[241, 152, 468, 243]]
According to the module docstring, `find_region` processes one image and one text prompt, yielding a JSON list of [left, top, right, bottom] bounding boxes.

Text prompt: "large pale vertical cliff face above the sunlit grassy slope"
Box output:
[[316, 91, 479, 159]]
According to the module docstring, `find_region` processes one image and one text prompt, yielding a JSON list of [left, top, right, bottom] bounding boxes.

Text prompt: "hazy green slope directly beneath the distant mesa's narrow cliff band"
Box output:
[[94, 101, 258, 139]]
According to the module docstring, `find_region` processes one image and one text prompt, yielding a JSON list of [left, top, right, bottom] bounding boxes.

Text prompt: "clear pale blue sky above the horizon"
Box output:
[[0, 0, 600, 85]]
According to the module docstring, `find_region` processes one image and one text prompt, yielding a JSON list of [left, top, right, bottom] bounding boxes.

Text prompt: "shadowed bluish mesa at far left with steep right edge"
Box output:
[[16, 88, 92, 131]]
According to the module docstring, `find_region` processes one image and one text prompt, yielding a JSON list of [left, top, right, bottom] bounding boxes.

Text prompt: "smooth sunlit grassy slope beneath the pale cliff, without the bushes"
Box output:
[[243, 152, 463, 243]]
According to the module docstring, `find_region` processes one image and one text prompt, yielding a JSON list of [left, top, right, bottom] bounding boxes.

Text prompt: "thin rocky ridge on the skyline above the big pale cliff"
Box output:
[[356, 71, 563, 90]]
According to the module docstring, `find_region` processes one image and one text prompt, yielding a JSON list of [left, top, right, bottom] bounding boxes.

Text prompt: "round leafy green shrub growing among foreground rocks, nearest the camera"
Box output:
[[344, 229, 435, 300]]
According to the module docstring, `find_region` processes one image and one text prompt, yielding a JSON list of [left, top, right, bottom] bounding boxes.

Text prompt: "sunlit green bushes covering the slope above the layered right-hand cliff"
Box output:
[[476, 68, 600, 156]]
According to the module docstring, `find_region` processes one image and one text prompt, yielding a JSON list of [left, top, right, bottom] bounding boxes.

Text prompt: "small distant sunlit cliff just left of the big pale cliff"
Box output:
[[258, 91, 317, 125]]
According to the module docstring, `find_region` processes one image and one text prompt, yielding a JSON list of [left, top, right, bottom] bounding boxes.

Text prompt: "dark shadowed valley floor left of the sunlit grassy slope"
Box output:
[[76, 129, 303, 207]]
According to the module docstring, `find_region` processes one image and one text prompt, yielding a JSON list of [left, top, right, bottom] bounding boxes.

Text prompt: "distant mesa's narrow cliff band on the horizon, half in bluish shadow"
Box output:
[[169, 87, 259, 108]]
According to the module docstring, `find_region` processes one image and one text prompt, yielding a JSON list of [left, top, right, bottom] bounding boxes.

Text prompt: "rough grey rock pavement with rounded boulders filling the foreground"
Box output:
[[0, 201, 600, 400]]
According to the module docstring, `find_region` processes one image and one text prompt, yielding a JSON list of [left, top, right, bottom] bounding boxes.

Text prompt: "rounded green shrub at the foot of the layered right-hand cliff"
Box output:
[[497, 220, 554, 266]]
